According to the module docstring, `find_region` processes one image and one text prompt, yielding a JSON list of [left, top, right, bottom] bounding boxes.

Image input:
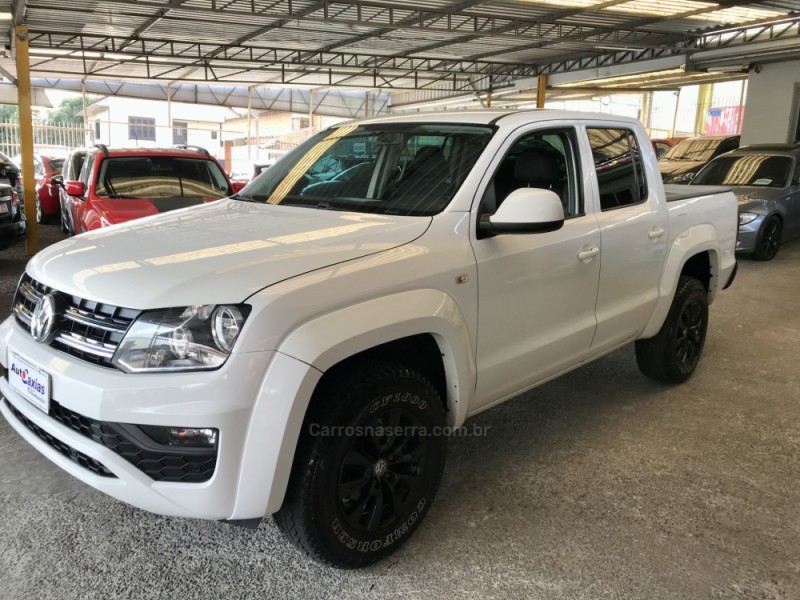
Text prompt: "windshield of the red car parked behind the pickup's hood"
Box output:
[[95, 156, 231, 199]]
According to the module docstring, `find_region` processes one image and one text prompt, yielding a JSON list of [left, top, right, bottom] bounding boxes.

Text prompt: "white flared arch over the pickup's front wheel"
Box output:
[[231, 290, 476, 519]]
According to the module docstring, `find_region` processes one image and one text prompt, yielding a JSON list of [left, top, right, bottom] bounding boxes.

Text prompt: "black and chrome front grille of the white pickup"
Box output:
[[12, 273, 139, 368]]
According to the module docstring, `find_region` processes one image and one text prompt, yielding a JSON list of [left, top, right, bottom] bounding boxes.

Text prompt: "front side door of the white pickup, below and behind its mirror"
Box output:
[[473, 124, 600, 408]]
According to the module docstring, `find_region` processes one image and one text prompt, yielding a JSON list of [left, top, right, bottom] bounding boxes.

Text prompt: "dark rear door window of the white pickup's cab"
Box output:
[[586, 128, 647, 210]]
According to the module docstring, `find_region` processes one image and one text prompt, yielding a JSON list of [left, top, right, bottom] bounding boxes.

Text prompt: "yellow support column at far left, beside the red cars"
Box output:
[[14, 25, 39, 256]]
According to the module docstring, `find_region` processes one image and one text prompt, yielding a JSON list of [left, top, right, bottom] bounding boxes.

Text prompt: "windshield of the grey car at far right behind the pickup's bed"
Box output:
[[692, 154, 792, 187]]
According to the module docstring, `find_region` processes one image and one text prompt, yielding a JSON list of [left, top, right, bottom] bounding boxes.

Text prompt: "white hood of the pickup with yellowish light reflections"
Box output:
[[27, 199, 431, 309]]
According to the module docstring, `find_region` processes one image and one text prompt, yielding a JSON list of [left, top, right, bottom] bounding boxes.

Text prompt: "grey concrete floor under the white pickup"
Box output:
[[0, 221, 800, 600]]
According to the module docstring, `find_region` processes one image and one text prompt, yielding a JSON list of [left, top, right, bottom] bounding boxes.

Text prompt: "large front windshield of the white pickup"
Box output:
[[237, 123, 494, 216]]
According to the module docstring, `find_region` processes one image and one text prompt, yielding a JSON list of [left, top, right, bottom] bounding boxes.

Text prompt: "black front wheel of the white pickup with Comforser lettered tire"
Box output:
[[275, 363, 447, 568]]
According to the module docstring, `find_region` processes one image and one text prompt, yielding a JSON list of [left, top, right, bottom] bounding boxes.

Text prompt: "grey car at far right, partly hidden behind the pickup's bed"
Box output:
[[692, 144, 800, 260]]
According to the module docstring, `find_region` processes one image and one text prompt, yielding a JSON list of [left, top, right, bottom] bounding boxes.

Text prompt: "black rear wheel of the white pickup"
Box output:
[[636, 275, 708, 383]]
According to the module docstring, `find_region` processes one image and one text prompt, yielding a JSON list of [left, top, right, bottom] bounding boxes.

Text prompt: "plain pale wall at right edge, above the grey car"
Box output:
[[742, 60, 800, 145]]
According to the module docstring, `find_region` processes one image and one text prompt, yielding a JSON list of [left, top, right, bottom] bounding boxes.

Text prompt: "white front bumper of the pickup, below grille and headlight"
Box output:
[[0, 317, 274, 519]]
